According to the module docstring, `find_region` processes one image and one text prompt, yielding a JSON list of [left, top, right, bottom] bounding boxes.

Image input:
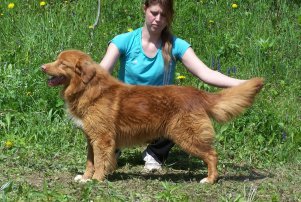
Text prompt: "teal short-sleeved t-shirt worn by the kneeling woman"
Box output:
[[110, 28, 190, 86]]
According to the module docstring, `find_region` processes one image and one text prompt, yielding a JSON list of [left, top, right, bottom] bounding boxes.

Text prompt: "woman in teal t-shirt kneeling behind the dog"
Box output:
[[100, 0, 244, 170]]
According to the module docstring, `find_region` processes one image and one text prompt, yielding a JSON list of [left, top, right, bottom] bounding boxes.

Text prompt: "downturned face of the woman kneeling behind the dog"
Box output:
[[144, 4, 167, 34]]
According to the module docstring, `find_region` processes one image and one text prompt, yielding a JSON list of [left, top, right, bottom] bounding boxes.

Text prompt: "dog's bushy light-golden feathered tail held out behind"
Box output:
[[207, 78, 264, 122]]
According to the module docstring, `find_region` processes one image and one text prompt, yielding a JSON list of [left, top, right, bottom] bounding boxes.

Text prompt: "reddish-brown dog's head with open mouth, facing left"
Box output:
[[41, 50, 96, 87]]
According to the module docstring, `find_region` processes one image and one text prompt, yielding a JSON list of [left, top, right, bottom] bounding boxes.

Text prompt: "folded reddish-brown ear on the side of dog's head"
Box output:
[[75, 60, 96, 84]]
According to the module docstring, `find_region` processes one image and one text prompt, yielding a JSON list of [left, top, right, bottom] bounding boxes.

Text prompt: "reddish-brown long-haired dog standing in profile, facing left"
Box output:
[[41, 50, 264, 183]]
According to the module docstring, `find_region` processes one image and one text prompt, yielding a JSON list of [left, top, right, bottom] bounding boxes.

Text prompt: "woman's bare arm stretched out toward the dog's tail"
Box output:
[[182, 48, 245, 88]]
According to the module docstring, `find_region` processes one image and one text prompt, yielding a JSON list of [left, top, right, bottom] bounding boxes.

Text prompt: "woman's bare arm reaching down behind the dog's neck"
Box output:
[[100, 43, 120, 72]]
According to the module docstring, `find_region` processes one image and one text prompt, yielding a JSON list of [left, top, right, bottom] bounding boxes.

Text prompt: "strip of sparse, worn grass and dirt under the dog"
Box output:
[[0, 148, 301, 201]]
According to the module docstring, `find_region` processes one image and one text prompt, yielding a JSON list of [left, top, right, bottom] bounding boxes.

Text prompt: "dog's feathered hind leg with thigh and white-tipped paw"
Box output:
[[170, 115, 218, 183]]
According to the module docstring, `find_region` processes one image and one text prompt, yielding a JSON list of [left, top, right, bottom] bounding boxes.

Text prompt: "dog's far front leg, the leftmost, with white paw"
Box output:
[[74, 138, 94, 182]]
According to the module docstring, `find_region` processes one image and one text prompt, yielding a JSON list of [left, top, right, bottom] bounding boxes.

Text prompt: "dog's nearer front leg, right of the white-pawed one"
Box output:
[[92, 135, 116, 181]]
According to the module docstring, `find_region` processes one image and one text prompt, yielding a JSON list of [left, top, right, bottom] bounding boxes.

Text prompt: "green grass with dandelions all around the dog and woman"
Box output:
[[0, 0, 301, 201]]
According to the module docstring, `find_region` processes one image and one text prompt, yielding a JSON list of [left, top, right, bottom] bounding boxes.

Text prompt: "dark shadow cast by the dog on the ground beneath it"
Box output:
[[108, 149, 272, 182]]
